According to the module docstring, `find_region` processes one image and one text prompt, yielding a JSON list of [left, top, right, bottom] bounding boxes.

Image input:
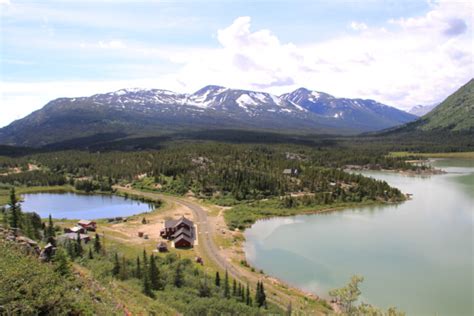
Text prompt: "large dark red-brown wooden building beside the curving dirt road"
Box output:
[[160, 216, 195, 248]]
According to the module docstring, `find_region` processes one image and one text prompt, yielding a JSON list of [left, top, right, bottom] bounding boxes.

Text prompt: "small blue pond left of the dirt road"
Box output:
[[21, 193, 153, 219]]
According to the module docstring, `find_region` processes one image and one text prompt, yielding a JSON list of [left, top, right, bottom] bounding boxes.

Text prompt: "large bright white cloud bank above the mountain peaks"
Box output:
[[165, 1, 474, 109]]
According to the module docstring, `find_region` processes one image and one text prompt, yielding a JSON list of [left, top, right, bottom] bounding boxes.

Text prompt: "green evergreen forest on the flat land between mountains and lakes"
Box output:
[[0, 142, 408, 201]]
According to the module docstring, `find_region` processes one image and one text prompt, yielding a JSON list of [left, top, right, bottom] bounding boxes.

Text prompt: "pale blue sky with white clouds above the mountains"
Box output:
[[0, 0, 474, 127]]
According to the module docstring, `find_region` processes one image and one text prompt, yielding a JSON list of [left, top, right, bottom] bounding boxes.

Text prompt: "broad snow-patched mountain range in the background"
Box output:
[[0, 86, 416, 147]]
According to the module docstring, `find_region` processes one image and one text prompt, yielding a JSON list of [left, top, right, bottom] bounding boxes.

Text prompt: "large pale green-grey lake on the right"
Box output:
[[245, 159, 474, 315]]
